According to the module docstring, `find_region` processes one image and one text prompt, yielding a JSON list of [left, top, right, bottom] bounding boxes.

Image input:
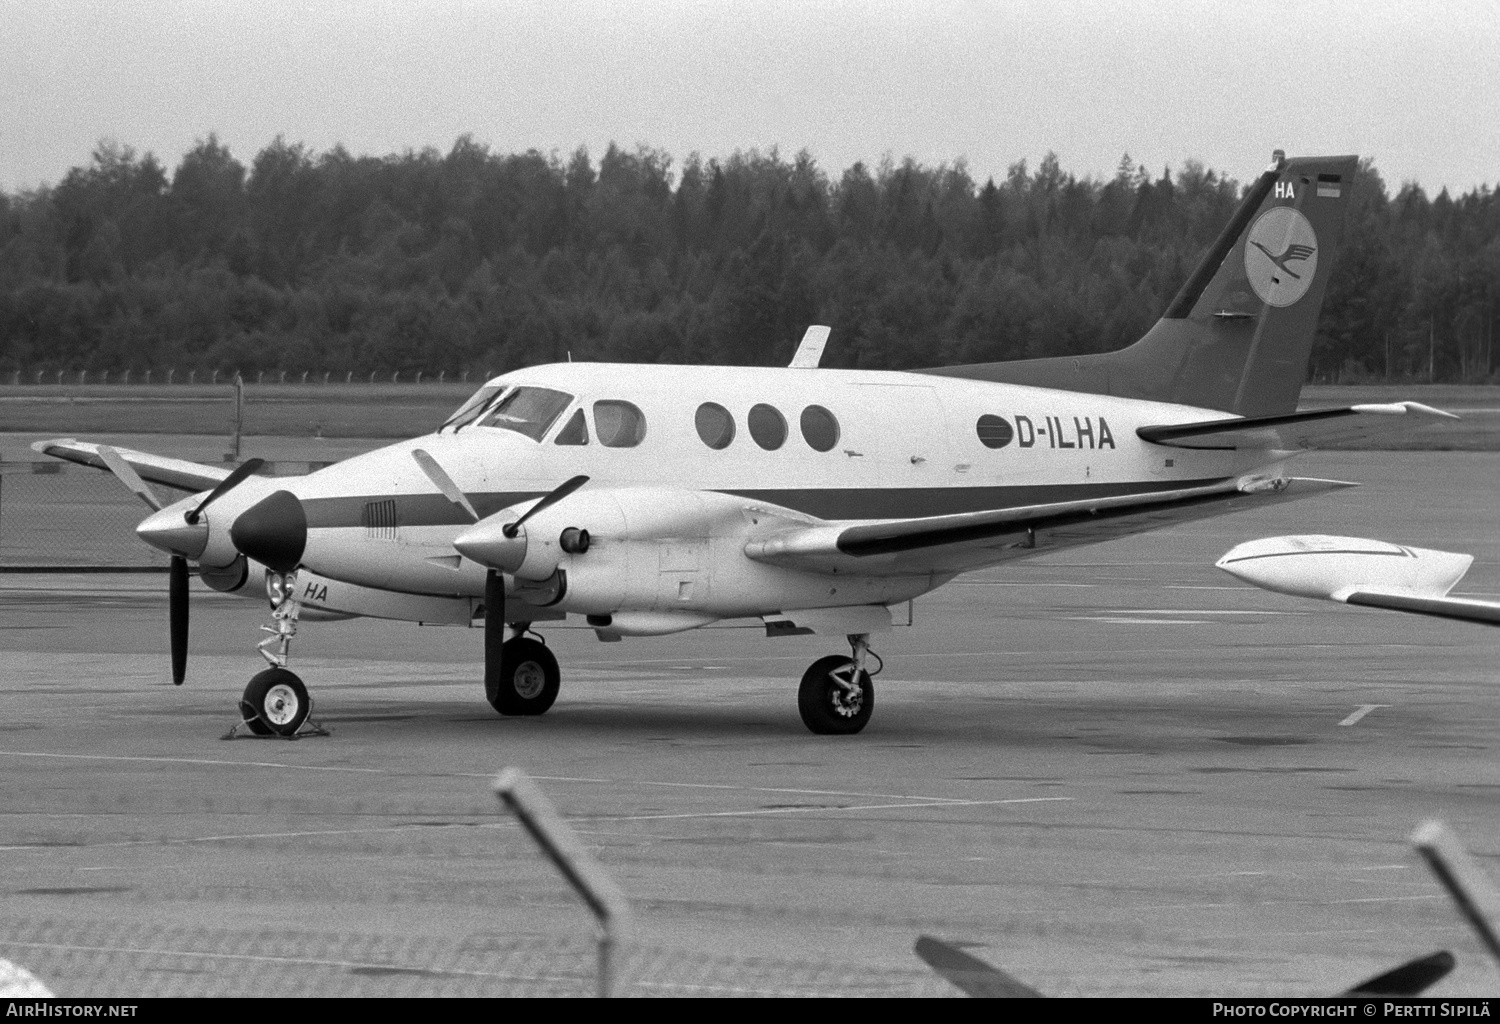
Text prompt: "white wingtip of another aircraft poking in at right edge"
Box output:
[[1215, 534, 1500, 625]]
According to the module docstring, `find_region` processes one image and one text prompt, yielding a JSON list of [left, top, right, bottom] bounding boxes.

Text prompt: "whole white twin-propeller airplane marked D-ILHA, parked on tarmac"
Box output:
[[36, 151, 1446, 735]]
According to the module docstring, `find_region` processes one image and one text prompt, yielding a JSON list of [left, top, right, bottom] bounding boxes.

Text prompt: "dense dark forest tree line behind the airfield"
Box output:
[[0, 136, 1500, 381]]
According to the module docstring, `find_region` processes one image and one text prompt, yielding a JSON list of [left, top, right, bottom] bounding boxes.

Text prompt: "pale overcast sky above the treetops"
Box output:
[[0, 0, 1500, 193]]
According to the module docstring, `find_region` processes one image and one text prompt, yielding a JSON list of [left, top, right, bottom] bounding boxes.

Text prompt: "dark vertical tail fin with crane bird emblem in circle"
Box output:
[[927, 150, 1358, 417]]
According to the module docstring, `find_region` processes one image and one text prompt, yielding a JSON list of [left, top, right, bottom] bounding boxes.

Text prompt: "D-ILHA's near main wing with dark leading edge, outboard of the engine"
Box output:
[[744, 477, 1356, 576]]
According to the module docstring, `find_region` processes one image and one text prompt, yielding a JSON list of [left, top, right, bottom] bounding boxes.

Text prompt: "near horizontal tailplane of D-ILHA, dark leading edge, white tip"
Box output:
[[1136, 402, 1458, 451]]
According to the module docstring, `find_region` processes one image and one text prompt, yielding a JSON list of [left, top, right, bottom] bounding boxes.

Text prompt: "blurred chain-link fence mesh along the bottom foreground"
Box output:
[[0, 918, 960, 999]]
